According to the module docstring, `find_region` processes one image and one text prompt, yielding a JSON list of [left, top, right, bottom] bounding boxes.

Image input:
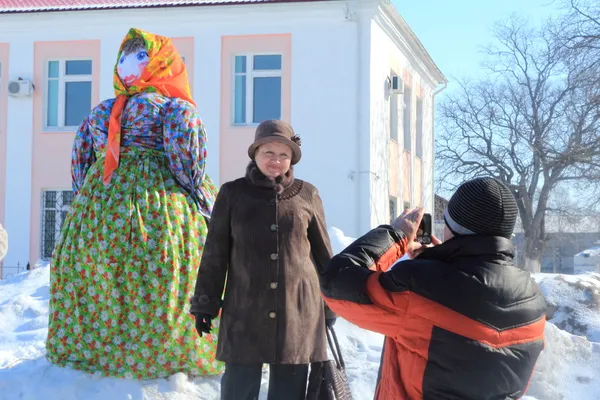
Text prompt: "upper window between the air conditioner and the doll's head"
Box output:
[[46, 60, 92, 129]]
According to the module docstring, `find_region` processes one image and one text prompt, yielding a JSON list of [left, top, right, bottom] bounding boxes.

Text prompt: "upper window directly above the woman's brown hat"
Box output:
[[233, 54, 281, 125]]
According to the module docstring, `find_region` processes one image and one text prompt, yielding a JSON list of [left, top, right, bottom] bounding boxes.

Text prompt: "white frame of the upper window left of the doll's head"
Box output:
[[43, 57, 94, 132]]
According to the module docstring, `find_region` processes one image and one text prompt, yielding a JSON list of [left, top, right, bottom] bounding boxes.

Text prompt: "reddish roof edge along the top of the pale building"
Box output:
[[0, 0, 316, 13]]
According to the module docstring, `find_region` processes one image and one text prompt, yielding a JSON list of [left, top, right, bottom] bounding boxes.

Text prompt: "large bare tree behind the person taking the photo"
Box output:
[[437, 18, 600, 271]]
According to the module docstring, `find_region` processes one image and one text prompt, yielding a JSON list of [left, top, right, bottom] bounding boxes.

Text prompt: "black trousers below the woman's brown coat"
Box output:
[[221, 364, 308, 400]]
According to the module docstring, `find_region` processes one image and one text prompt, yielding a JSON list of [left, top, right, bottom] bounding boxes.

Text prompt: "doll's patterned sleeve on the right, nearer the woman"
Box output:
[[163, 99, 209, 212]]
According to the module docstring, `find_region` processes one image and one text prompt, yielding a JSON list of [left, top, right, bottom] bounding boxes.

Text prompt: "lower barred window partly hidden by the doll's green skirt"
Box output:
[[42, 190, 74, 260]]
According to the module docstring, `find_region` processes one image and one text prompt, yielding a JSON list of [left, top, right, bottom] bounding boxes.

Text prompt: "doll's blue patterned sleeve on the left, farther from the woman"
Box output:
[[71, 99, 114, 194]]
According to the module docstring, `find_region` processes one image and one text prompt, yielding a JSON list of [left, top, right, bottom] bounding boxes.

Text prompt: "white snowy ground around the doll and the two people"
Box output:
[[0, 228, 600, 400]]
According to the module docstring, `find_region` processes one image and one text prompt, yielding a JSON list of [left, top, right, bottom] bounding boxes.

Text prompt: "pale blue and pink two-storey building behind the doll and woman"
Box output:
[[0, 0, 446, 272]]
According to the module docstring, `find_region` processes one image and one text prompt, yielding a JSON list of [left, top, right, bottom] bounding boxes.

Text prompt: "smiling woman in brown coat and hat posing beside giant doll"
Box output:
[[190, 120, 335, 400]]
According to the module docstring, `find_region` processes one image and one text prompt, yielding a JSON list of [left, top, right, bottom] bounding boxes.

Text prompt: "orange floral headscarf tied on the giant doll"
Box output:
[[103, 28, 195, 185]]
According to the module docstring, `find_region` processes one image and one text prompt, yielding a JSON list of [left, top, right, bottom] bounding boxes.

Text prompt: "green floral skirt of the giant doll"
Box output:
[[46, 150, 224, 379]]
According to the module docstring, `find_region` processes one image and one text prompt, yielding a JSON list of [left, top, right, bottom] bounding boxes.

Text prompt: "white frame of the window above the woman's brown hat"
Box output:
[[230, 52, 284, 126]]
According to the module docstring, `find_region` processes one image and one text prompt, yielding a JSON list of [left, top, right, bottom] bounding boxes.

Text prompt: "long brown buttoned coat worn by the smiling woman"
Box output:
[[191, 163, 332, 364]]
